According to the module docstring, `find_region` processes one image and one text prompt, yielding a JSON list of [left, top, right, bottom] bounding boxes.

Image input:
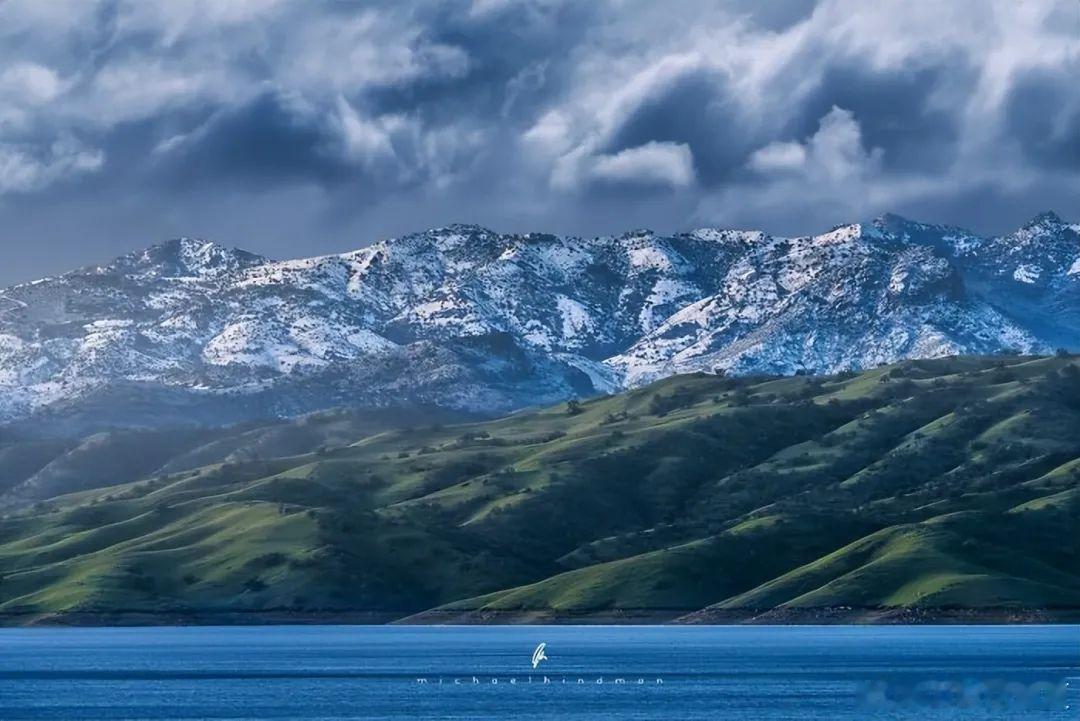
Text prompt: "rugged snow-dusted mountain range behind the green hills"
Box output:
[[0, 214, 1080, 424]]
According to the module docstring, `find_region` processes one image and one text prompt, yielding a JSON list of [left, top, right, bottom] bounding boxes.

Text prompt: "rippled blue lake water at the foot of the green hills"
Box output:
[[0, 626, 1080, 721]]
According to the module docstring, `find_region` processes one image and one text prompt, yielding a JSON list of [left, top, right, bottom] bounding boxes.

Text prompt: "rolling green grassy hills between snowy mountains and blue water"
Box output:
[[0, 357, 1080, 623]]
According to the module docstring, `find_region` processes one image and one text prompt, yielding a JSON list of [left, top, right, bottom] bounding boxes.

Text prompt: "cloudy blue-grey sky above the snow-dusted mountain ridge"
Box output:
[[0, 0, 1080, 285]]
